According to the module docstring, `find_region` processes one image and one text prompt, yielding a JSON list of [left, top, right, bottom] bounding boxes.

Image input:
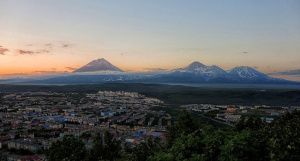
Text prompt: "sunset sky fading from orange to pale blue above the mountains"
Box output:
[[0, 0, 300, 80]]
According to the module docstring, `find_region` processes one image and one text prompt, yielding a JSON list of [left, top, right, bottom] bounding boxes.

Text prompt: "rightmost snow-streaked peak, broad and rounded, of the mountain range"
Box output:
[[228, 66, 269, 79]]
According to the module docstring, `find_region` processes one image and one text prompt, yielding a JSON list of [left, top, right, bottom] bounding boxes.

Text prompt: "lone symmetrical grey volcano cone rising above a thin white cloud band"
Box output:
[[74, 58, 123, 73]]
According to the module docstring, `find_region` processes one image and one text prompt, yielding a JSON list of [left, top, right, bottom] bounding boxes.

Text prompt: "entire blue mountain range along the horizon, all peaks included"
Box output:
[[0, 58, 296, 84]]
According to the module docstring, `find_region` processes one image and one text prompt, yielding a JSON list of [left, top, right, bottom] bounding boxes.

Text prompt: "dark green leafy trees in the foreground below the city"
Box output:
[[47, 112, 300, 161]]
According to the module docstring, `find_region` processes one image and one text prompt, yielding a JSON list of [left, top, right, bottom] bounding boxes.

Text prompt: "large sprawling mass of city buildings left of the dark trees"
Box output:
[[0, 91, 172, 161]]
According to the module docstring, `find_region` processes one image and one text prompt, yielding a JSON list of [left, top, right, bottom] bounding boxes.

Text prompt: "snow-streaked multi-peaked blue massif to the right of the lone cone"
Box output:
[[150, 62, 287, 83]]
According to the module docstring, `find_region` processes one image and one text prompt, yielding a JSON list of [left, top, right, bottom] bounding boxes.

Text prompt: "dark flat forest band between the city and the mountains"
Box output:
[[0, 83, 300, 106]]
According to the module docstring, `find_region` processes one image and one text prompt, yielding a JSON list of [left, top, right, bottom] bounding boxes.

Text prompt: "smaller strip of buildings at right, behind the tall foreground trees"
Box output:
[[181, 104, 300, 124]]
